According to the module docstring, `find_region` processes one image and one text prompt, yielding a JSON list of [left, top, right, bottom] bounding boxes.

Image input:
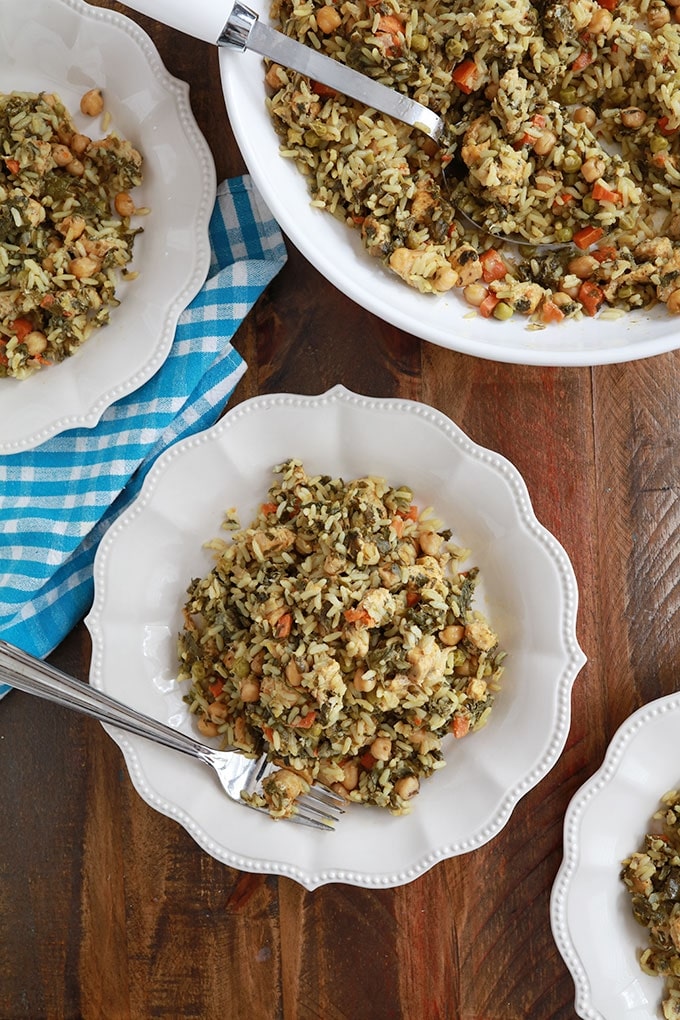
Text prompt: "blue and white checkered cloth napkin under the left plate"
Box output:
[[0, 177, 286, 697]]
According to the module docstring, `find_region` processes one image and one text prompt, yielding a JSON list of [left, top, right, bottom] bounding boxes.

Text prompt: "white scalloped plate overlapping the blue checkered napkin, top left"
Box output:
[[0, 0, 216, 454]]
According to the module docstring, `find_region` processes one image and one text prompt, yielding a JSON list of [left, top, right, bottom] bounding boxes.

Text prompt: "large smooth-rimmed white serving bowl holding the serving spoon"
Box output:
[[220, 0, 680, 365]]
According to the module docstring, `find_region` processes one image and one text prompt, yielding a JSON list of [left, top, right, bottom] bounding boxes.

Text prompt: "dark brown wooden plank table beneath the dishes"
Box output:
[[0, 2, 680, 1020]]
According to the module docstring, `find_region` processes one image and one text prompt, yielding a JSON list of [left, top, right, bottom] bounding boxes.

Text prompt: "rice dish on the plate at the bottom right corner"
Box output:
[[621, 789, 680, 1020]]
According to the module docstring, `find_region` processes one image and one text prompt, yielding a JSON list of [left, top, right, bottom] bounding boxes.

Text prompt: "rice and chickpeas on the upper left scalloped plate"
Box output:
[[0, 90, 146, 379]]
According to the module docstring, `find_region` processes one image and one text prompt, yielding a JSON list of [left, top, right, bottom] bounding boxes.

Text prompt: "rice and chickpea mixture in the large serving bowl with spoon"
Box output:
[[266, 0, 680, 328]]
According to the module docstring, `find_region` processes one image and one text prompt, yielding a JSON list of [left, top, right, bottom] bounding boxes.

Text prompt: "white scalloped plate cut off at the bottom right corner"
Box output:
[[551, 695, 680, 1020]]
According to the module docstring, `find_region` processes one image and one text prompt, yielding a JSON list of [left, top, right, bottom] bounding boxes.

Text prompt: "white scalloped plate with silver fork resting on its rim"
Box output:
[[87, 387, 584, 888]]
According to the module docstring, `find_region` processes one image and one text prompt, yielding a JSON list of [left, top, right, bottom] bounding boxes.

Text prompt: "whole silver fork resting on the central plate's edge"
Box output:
[[0, 641, 345, 831]]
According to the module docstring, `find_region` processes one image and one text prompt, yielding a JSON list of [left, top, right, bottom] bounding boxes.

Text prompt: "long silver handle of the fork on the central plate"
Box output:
[[0, 641, 211, 761]]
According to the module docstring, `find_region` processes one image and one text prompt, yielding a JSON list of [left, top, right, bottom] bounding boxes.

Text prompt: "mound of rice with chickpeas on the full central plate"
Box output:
[[178, 460, 504, 817]]
